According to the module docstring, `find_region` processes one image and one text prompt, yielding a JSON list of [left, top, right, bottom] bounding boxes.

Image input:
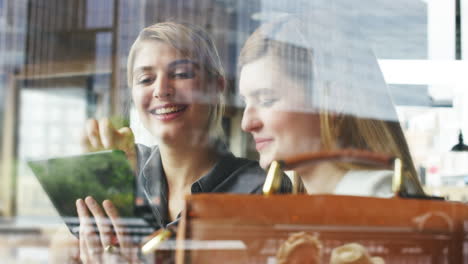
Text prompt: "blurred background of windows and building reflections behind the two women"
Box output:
[[0, 0, 468, 263]]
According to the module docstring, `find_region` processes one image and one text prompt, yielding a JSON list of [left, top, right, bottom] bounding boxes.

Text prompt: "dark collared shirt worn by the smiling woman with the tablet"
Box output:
[[133, 145, 292, 227]]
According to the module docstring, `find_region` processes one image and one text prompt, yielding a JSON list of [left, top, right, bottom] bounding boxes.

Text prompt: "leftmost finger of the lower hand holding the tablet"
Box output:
[[76, 199, 102, 260]]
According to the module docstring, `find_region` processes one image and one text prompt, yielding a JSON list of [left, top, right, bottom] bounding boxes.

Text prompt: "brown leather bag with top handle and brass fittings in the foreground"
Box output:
[[144, 150, 468, 264]]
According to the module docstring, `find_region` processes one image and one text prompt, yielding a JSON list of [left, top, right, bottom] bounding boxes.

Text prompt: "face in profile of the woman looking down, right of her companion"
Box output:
[[239, 56, 320, 168]]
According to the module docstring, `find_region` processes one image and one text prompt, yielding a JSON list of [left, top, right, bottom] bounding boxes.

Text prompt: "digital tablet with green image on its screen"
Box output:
[[28, 150, 153, 239]]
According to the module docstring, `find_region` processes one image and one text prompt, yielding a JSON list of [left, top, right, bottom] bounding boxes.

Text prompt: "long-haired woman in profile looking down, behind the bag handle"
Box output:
[[239, 14, 422, 196]]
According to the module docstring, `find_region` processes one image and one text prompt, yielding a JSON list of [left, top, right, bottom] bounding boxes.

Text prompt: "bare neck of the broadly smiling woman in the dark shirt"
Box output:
[[159, 141, 217, 191]]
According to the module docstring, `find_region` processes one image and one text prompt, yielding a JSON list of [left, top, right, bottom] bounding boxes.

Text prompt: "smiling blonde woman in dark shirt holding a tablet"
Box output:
[[70, 22, 288, 263]]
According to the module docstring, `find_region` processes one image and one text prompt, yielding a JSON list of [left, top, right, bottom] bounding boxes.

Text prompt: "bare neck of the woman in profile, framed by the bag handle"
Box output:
[[297, 162, 347, 194]]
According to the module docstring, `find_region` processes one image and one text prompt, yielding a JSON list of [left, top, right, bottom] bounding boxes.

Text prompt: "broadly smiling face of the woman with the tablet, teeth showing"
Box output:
[[132, 41, 210, 143]]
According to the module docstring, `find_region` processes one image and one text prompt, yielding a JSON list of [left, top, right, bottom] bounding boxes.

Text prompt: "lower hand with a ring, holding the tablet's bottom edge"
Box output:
[[76, 196, 138, 263]]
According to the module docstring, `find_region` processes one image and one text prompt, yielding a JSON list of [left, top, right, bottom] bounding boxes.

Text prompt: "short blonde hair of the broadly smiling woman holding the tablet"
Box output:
[[127, 22, 225, 138]]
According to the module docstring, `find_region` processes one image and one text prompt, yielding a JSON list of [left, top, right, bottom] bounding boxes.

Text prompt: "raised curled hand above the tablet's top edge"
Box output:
[[81, 118, 137, 171]]
